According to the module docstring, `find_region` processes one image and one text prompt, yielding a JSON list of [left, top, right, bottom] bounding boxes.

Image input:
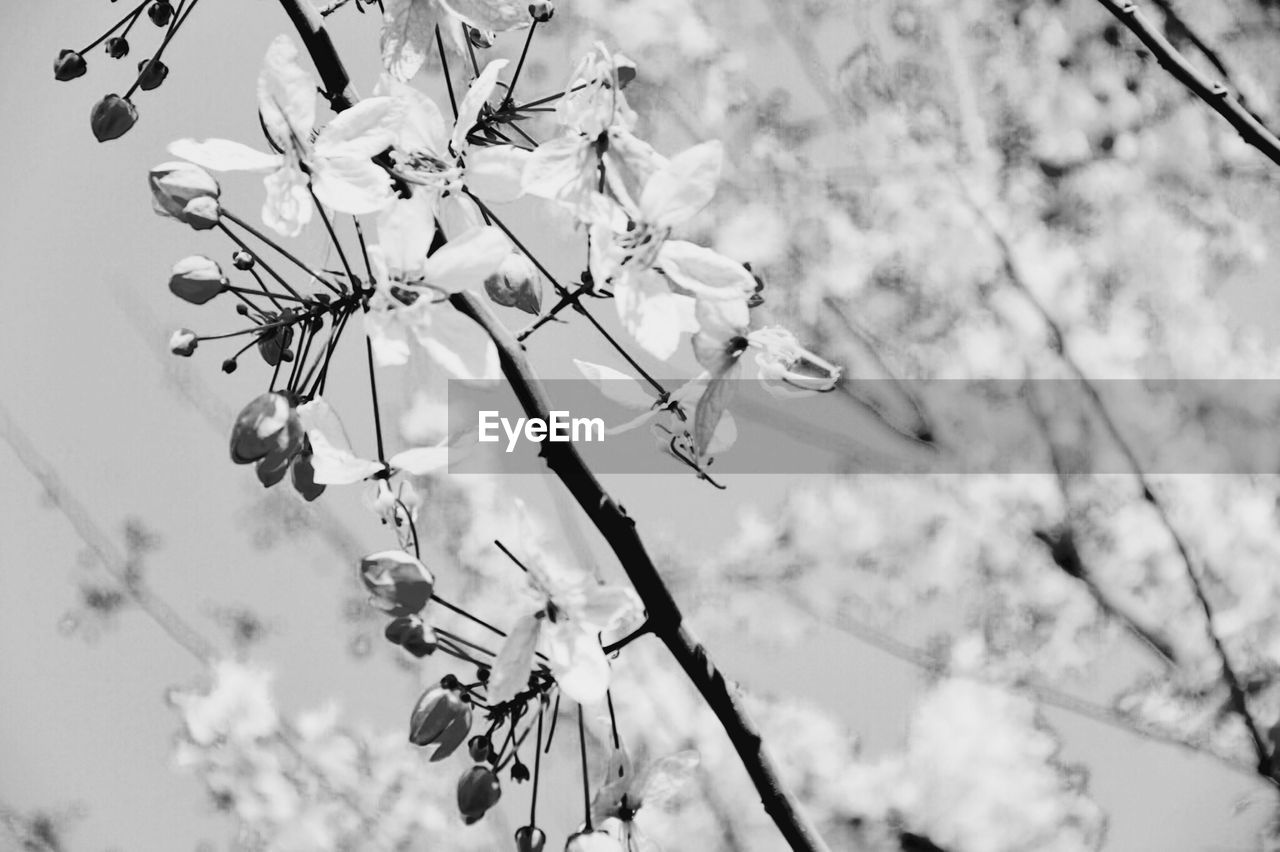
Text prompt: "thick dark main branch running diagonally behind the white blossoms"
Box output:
[[270, 0, 827, 852]]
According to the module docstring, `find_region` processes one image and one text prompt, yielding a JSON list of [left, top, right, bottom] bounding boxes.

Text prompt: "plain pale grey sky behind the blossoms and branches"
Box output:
[[0, 0, 1277, 852]]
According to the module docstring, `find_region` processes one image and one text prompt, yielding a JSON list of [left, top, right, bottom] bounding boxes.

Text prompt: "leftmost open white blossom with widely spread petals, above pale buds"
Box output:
[[169, 36, 402, 237]]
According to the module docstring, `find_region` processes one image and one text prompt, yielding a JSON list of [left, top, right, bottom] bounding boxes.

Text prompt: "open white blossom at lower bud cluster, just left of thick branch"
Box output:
[[488, 558, 640, 704]]
